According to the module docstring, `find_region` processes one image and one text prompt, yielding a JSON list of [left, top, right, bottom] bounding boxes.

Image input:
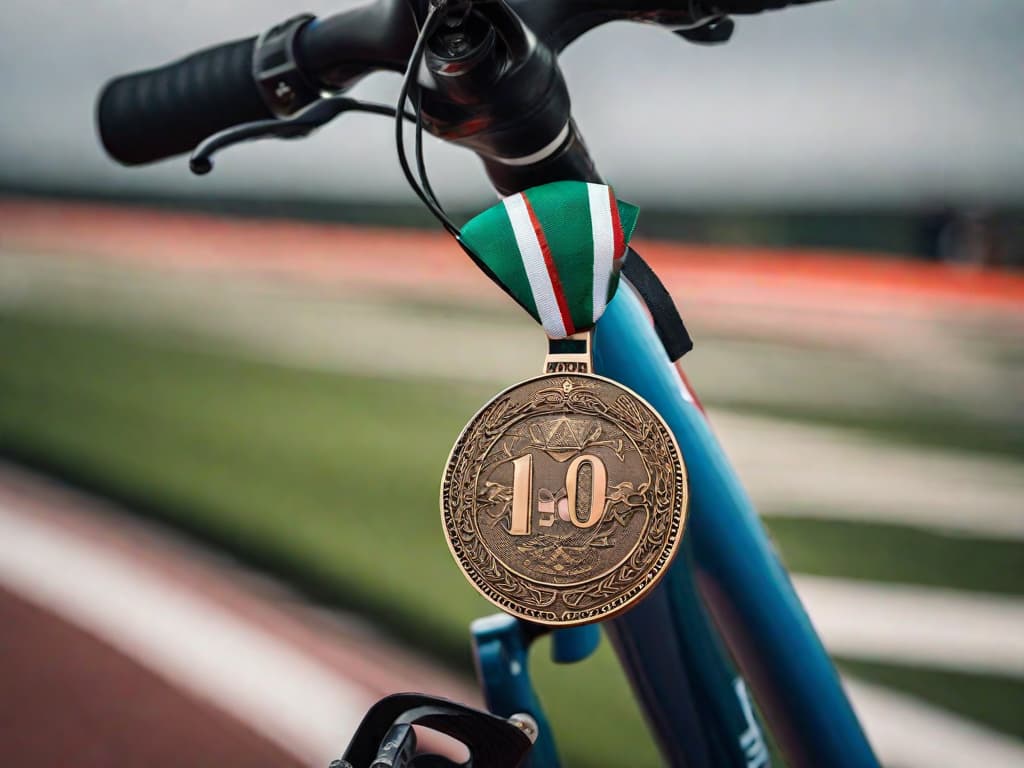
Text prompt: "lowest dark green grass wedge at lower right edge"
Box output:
[[839, 658, 1024, 738]]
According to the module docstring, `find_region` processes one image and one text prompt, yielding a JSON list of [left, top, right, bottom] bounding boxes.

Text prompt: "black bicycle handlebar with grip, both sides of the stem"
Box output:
[[96, 0, 817, 165]]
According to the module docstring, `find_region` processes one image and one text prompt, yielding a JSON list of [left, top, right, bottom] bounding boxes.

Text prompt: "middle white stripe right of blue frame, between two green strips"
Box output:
[[794, 575, 1024, 678]]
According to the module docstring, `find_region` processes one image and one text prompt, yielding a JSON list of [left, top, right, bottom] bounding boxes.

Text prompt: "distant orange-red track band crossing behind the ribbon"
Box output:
[[6, 199, 1024, 314]]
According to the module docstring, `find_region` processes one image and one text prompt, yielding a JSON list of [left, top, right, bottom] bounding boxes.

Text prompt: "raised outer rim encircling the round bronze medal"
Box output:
[[438, 371, 690, 627]]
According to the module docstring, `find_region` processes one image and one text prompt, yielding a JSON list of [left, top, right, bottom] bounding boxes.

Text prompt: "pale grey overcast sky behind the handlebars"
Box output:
[[0, 0, 1024, 205]]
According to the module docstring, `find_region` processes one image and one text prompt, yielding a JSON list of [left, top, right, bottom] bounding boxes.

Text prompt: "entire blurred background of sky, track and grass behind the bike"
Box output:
[[0, 0, 1024, 767]]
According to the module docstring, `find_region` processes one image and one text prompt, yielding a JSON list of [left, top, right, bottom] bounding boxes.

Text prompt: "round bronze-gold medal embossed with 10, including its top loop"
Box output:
[[440, 332, 688, 626]]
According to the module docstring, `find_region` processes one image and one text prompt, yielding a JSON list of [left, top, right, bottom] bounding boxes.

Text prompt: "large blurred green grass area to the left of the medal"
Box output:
[[0, 322, 483, 647]]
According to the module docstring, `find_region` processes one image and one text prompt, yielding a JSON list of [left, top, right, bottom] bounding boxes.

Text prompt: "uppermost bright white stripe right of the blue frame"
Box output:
[[711, 410, 1024, 541]]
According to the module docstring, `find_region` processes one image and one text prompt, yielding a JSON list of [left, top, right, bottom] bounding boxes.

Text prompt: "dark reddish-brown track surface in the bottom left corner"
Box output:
[[0, 589, 301, 768]]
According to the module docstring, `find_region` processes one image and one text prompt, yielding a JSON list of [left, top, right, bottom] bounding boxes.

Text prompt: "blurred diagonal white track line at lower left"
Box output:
[[0, 506, 372, 765]]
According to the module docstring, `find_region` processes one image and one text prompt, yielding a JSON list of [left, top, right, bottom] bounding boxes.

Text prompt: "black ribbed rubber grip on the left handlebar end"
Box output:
[[96, 38, 273, 165]]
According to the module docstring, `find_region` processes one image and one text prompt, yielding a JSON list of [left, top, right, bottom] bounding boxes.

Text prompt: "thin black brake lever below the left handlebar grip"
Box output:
[[188, 96, 416, 176]]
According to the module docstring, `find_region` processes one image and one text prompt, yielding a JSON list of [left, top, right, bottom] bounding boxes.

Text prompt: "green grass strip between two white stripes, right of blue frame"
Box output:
[[765, 517, 1024, 595]]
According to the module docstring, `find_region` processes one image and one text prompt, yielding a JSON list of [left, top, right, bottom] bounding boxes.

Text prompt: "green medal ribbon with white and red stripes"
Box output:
[[461, 181, 639, 339]]
